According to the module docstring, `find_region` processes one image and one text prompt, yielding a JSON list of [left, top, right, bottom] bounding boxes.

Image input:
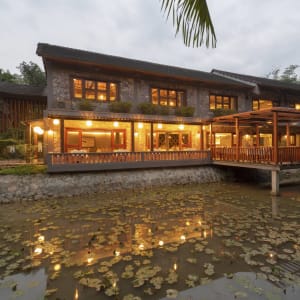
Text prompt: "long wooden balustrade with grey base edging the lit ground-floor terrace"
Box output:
[[47, 150, 211, 173]]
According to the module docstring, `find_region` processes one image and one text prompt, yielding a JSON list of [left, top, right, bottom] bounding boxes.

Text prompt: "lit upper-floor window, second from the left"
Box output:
[[151, 88, 185, 107]]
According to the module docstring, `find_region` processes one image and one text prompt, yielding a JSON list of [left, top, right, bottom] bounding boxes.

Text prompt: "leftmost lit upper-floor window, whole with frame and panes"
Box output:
[[73, 78, 118, 101]]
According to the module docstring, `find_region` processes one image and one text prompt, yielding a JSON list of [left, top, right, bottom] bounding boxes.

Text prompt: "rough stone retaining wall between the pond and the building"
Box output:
[[0, 166, 228, 203]]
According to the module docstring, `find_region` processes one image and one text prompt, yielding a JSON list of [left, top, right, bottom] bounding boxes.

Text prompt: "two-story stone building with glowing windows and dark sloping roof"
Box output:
[[33, 43, 300, 169]]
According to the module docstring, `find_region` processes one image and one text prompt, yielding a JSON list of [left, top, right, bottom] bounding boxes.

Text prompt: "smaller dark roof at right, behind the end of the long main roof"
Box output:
[[211, 69, 300, 91]]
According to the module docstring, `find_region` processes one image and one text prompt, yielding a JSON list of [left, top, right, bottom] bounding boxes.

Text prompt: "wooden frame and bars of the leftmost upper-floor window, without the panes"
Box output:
[[71, 76, 120, 103]]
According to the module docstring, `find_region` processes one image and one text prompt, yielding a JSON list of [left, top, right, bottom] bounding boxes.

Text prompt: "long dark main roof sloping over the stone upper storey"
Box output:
[[36, 43, 248, 87]]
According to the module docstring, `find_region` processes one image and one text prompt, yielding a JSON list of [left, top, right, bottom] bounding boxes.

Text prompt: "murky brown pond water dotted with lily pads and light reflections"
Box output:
[[0, 183, 300, 300]]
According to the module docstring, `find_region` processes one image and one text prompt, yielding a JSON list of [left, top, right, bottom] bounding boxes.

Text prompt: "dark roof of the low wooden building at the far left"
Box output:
[[0, 81, 46, 97]]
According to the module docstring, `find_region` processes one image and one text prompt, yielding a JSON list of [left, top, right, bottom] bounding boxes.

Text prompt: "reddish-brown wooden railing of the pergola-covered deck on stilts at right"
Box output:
[[211, 147, 300, 164]]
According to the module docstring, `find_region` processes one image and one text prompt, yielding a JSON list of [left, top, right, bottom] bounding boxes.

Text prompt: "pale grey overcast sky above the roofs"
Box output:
[[0, 0, 300, 76]]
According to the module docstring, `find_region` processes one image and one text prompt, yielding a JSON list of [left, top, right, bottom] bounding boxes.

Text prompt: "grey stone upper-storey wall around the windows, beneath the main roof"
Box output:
[[47, 62, 251, 118]]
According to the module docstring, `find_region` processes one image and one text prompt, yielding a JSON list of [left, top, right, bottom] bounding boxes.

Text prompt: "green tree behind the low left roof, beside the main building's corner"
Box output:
[[17, 61, 46, 85]]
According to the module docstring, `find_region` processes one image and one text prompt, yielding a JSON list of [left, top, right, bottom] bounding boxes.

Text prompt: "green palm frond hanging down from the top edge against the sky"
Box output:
[[161, 0, 217, 47]]
